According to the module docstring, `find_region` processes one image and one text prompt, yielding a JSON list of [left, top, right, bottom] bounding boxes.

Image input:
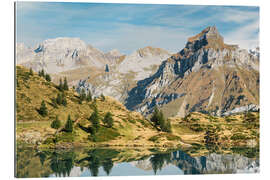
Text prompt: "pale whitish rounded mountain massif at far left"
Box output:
[[16, 38, 119, 74]]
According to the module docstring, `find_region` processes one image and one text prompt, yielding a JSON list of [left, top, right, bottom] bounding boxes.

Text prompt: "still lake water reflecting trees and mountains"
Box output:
[[16, 148, 259, 177]]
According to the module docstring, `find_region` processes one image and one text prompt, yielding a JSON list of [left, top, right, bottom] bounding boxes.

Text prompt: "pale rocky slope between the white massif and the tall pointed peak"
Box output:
[[76, 47, 169, 102]]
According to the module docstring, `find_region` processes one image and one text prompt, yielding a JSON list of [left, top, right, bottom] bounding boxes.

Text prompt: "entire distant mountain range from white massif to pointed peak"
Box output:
[[16, 26, 260, 117]]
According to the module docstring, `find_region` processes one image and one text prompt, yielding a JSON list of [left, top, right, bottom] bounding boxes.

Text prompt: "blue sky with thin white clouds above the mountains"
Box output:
[[16, 2, 259, 54]]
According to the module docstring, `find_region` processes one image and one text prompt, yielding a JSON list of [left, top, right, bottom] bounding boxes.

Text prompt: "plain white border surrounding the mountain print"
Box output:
[[0, 0, 270, 180]]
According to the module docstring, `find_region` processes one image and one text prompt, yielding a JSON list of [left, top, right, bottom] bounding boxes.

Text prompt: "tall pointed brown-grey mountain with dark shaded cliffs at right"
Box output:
[[125, 27, 259, 117]]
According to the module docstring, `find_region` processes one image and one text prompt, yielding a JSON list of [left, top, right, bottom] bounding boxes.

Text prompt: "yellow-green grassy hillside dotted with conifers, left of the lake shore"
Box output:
[[16, 66, 186, 148]]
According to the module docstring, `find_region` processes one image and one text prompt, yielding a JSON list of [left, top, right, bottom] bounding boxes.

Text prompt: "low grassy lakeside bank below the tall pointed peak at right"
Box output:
[[170, 112, 260, 153]]
